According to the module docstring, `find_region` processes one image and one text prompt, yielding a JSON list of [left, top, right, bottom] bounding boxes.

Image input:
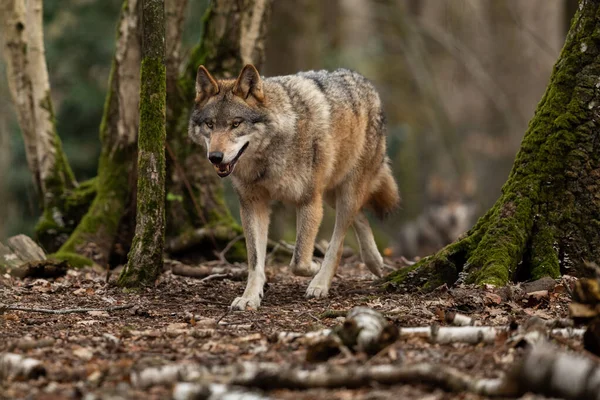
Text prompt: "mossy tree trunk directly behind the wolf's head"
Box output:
[[167, 0, 272, 257]]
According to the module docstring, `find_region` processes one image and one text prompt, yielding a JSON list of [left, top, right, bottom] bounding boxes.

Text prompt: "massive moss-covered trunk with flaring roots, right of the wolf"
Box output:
[[387, 0, 600, 289]]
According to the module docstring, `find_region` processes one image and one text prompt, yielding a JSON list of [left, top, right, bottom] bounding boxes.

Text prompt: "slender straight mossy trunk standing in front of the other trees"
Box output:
[[119, 0, 166, 287]]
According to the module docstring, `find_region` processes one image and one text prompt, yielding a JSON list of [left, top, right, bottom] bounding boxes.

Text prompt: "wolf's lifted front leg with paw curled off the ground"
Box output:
[[290, 196, 323, 276]]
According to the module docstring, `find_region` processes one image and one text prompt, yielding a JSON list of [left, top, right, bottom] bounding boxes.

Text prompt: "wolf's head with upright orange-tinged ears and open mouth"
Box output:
[[188, 64, 266, 178]]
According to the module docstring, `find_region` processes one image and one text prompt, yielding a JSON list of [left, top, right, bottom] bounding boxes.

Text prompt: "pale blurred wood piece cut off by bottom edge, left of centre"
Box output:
[[173, 382, 270, 400]]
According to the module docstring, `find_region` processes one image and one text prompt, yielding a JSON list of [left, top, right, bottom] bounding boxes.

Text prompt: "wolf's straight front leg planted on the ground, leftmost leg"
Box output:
[[231, 199, 269, 310]]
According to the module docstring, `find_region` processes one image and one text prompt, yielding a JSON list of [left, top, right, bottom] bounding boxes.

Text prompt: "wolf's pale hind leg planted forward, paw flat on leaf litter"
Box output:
[[306, 189, 360, 298]]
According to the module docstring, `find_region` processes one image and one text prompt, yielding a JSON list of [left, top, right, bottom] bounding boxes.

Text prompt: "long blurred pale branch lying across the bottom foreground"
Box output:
[[131, 362, 507, 398]]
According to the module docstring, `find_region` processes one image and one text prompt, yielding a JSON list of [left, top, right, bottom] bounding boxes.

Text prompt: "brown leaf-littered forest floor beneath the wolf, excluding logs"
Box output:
[[0, 256, 582, 400]]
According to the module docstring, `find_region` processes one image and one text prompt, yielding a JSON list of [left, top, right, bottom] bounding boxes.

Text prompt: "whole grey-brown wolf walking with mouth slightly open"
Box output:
[[189, 65, 400, 310]]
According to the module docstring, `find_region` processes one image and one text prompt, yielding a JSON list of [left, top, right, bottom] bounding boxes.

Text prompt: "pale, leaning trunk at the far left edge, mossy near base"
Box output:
[[0, 0, 77, 222]]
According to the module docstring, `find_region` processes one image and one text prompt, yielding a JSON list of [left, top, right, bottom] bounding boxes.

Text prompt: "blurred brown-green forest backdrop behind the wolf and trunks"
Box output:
[[0, 0, 577, 256]]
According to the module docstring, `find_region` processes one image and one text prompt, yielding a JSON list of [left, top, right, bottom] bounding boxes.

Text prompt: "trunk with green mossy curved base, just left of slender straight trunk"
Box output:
[[51, 0, 141, 266]]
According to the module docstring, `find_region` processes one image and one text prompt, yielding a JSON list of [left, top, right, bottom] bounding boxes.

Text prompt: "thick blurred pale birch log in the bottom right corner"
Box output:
[[507, 343, 600, 400]]
